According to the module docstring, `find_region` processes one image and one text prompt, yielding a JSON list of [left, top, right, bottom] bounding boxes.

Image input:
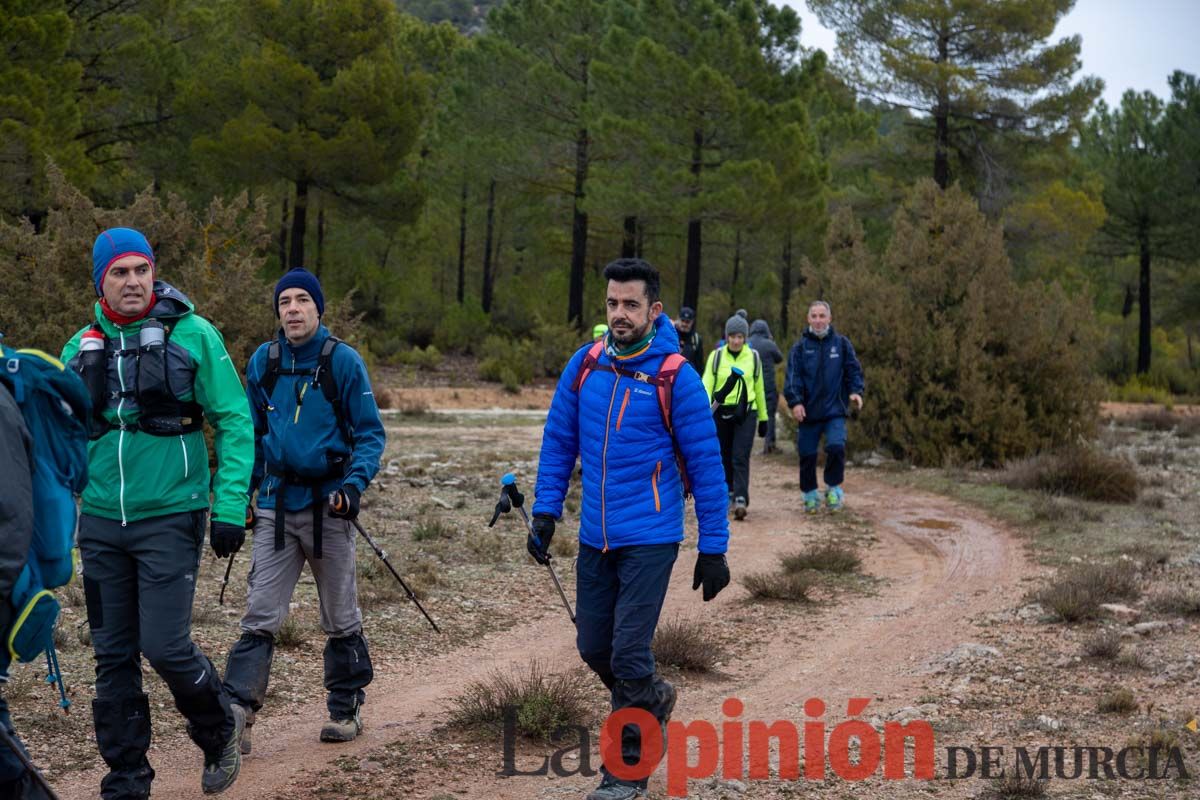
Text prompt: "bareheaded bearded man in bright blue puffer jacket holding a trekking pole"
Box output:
[[528, 259, 730, 800]]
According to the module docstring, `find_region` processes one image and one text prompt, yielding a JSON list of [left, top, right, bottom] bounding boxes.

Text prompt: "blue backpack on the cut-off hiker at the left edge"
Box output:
[[0, 344, 91, 708]]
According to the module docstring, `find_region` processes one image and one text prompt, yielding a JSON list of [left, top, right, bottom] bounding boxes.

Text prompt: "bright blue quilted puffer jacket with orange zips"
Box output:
[[533, 314, 730, 553]]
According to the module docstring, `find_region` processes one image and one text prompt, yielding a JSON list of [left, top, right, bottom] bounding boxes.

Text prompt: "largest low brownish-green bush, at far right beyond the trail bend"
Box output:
[[1000, 445, 1138, 503]]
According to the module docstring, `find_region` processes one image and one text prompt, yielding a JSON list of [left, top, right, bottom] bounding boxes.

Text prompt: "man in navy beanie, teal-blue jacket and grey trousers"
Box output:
[[224, 269, 384, 753]]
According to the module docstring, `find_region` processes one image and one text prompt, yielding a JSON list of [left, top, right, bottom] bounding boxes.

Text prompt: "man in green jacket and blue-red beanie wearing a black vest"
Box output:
[[62, 228, 254, 800]]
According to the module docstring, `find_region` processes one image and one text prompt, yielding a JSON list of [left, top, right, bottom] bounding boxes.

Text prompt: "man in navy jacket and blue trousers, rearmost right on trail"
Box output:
[[784, 300, 863, 513]]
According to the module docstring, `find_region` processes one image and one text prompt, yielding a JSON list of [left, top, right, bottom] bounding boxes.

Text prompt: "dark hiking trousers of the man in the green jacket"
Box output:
[[79, 511, 234, 800]]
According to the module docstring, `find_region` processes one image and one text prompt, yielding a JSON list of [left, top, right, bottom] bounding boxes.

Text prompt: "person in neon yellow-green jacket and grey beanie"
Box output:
[[702, 314, 767, 519]]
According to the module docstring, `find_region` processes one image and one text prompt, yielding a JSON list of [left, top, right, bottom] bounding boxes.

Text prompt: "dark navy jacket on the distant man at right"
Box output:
[[784, 325, 863, 422]]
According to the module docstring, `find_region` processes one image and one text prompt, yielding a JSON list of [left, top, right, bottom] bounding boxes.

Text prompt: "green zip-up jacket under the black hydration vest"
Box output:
[[62, 281, 254, 525]]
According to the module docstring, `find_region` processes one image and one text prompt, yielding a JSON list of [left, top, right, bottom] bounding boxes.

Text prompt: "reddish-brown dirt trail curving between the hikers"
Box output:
[[60, 431, 1030, 800]]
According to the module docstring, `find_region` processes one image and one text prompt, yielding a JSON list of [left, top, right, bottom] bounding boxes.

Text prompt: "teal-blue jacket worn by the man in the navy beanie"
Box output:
[[246, 325, 385, 511]]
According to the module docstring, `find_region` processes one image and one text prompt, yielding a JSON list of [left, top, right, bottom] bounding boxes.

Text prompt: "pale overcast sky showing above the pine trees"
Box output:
[[785, 0, 1200, 106]]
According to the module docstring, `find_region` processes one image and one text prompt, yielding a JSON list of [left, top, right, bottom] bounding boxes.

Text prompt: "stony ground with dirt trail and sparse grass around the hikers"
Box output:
[[6, 371, 1200, 800]]
